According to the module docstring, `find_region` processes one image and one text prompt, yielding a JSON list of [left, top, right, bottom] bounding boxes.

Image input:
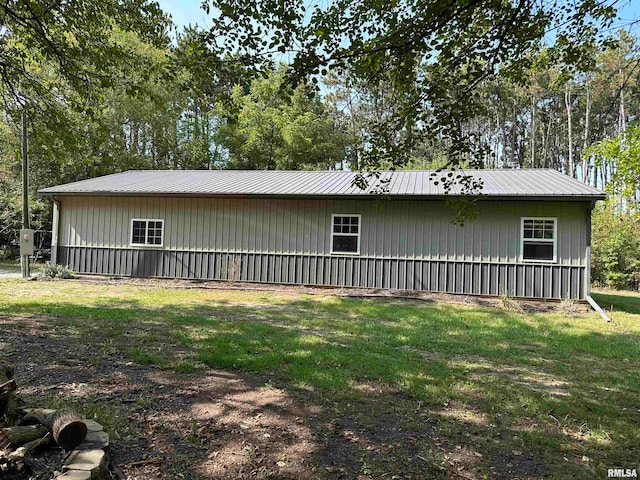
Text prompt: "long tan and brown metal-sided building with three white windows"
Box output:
[[40, 169, 604, 299]]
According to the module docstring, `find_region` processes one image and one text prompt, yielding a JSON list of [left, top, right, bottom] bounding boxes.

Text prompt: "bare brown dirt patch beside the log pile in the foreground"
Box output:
[[0, 316, 320, 480]]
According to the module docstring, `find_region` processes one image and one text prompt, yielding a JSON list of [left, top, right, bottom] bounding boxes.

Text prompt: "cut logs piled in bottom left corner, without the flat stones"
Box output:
[[0, 363, 87, 477]]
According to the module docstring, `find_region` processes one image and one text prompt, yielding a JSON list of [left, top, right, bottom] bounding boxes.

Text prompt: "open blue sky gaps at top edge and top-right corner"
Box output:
[[159, 0, 640, 35]]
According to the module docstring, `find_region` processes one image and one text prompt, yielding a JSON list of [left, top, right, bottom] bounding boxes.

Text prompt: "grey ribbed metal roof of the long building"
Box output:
[[40, 169, 604, 200]]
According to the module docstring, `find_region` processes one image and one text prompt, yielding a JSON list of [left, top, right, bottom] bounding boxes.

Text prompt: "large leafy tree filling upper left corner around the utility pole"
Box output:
[[0, 0, 169, 244]]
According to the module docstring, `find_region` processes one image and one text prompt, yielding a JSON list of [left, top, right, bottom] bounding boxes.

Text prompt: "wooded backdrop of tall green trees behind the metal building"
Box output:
[[0, 0, 640, 287]]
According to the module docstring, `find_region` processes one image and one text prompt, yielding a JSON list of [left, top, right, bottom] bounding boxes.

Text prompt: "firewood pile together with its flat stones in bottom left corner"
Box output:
[[0, 363, 119, 480]]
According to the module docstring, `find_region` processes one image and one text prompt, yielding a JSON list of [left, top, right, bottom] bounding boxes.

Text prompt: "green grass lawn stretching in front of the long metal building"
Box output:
[[0, 280, 640, 478]]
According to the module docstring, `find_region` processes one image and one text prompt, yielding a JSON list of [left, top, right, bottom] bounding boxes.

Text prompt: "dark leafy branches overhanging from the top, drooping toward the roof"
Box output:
[[206, 0, 615, 178]]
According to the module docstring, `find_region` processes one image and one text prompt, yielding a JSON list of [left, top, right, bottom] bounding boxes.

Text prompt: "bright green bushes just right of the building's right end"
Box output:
[[591, 205, 640, 290]]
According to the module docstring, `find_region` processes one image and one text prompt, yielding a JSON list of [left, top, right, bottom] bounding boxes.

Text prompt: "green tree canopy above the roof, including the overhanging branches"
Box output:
[[0, 0, 640, 234]]
